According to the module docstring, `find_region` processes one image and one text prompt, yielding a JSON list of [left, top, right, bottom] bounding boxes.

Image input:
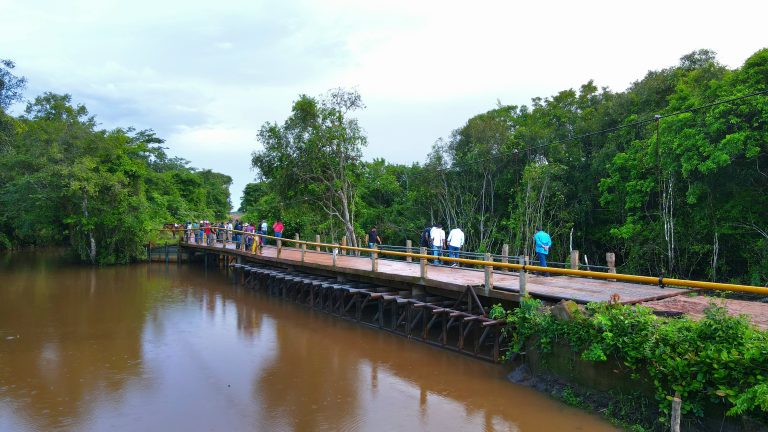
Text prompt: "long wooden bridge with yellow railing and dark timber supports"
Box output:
[[166, 228, 768, 361]]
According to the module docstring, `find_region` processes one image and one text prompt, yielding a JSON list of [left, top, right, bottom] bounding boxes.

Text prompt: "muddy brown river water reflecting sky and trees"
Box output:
[[0, 253, 615, 431]]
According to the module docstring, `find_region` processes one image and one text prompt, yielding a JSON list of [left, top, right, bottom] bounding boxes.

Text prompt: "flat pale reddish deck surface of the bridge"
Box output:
[[184, 243, 690, 303]]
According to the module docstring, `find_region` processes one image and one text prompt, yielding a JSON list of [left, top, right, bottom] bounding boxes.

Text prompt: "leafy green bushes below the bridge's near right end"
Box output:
[[490, 298, 768, 430]]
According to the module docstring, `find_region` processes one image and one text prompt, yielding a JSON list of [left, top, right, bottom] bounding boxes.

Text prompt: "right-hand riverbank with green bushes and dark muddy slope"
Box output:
[[492, 299, 768, 431]]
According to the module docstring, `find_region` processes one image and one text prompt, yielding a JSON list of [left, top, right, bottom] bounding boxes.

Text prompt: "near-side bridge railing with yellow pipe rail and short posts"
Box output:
[[165, 227, 768, 296]]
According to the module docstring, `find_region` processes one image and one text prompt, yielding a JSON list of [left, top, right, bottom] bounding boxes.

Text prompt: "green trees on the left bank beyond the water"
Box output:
[[0, 61, 232, 264]]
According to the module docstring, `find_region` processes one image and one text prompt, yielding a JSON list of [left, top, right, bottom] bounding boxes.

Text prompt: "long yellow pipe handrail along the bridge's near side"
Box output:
[[162, 227, 768, 295]]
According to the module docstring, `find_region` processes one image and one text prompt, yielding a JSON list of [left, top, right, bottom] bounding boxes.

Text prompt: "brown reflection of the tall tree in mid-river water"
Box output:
[[254, 298, 360, 431]]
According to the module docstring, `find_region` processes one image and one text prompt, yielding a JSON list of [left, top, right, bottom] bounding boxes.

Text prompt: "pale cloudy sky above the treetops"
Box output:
[[0, 0, 768, 208]]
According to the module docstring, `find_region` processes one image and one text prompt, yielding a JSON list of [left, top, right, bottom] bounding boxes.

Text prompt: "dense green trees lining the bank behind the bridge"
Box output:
[[240, 49, 768, 285]]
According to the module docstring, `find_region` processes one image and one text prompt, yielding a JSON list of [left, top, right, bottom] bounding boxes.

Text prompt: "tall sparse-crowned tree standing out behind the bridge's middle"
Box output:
[[251, 89, 367, 246]]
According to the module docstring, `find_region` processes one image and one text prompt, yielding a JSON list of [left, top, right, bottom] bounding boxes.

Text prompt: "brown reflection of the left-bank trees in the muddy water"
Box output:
[[0, 255, 156, 430]]
